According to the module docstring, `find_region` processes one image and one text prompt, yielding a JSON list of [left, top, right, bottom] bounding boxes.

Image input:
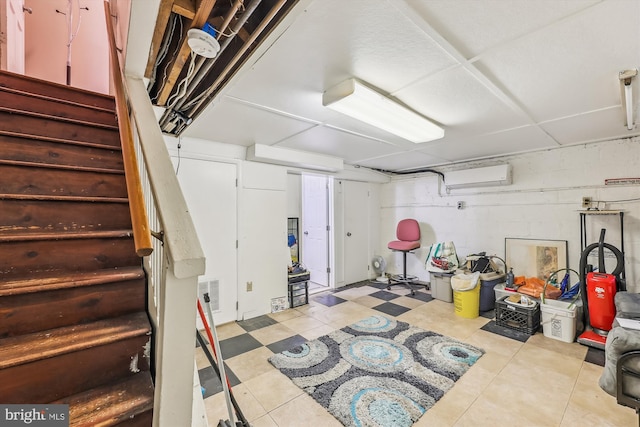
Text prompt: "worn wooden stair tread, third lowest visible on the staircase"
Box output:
[[0, 266, 144, 297]]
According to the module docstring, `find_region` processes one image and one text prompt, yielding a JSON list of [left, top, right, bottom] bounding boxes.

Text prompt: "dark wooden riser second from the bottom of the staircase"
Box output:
[[0, 279, 146, 338]]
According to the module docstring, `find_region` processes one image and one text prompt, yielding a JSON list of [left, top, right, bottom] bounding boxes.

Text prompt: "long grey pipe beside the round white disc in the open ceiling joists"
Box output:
[[160, 0, 262, 127]]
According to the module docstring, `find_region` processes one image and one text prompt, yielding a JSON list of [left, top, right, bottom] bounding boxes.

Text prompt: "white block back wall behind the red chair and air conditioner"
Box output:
[[380, 138, 640, 291]]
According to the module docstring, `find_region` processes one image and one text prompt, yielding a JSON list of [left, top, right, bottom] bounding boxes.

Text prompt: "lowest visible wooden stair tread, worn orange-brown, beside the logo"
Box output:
[[52, 372, 153, 426]]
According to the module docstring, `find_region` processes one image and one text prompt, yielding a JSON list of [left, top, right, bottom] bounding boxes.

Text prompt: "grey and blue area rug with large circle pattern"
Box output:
[[269, 315, 484, 427]]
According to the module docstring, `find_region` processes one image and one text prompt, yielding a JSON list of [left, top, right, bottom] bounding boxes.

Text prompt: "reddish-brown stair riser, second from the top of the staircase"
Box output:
[[0, 91, 118, 127]]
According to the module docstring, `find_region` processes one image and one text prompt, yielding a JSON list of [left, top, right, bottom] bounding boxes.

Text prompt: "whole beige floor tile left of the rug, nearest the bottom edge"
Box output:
[[243, 371, 304, 411]]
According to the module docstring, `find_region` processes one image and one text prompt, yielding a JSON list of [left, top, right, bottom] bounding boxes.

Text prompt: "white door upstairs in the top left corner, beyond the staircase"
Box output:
[[1, 0, 25, 74]]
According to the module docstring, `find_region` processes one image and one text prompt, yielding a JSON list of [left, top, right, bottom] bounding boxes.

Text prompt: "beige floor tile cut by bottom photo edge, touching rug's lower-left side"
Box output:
[[269, 393, 342, 427]]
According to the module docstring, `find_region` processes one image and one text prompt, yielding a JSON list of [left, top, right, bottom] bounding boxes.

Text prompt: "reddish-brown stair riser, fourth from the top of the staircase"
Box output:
[[0, 135, 124, 171]]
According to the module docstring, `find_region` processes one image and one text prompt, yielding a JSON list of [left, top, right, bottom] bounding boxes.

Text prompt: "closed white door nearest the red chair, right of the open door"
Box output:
[[342, 181, 371, 285]]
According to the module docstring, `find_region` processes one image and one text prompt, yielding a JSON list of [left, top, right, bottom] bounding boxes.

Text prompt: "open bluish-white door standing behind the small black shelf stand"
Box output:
[[300, 175, 329, 286]]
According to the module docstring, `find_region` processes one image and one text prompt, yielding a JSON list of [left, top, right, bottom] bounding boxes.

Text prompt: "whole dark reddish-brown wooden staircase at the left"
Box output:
[[0, 71, 153, 426]]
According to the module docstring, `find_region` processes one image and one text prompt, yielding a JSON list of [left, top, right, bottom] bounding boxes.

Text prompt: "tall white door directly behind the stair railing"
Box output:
[[178, 158, 238, 325]]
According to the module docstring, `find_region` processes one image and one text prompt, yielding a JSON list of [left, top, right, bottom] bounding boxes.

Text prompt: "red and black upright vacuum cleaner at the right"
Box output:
[[578, 228, 626, 350]]
